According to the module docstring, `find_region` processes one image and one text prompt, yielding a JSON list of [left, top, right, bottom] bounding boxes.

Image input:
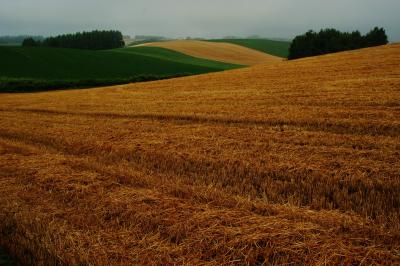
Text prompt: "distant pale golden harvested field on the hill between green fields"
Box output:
[[140, 40, 283, 65]]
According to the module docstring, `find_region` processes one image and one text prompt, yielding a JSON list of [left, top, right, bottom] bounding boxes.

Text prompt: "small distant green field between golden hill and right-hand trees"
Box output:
[[208, 39, 290, 58]]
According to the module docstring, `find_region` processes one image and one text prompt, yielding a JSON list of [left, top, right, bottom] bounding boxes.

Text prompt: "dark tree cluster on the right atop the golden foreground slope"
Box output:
[[288, 27, 388, 59]]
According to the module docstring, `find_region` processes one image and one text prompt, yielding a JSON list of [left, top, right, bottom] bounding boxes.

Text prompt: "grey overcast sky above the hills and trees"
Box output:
[[0, 0, 400, 41]]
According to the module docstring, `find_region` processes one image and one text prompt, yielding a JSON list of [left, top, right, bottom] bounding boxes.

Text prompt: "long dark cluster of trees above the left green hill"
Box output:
[[22, 30, 125, 50]]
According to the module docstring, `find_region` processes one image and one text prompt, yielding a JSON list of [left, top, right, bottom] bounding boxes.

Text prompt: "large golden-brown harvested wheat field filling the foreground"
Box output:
[[0, 45, 400, 265]]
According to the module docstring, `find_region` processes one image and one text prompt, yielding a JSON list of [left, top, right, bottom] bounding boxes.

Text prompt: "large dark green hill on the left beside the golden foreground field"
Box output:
[[0, 46, 241, 92]]
